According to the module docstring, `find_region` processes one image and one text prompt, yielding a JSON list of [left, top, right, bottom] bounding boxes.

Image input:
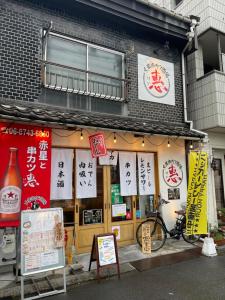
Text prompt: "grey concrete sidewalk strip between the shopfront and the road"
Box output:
[[0, 239, 202, 299]]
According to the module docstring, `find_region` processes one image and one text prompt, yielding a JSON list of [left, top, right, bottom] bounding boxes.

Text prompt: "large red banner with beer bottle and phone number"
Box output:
[[0, 123, 51, 226]]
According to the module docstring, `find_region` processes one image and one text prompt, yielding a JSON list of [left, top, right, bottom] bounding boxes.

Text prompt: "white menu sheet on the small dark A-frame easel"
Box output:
[[97, 235, 116, 267]]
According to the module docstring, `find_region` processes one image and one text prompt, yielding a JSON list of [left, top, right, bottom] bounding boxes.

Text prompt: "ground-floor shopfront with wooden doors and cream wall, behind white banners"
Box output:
[[51, 129, 187, 253]]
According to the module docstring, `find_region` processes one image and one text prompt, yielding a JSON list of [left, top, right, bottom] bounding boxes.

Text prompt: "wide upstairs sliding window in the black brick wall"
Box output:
[[44, 33, 126, 100]]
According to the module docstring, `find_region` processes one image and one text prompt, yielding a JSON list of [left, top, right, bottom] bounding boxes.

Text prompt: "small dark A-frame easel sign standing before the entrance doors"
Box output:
[[89, 233, 120, 280]]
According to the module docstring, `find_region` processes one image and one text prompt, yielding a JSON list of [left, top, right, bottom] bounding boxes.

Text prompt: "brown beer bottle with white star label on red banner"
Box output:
[[0, 148, 22, 221]]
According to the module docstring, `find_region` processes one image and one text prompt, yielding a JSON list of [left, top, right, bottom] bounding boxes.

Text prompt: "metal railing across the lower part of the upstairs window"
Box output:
[[40, 61, 128, 101]]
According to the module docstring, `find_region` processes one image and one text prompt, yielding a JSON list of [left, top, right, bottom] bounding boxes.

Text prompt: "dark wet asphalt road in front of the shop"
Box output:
[[46, 255, 225, 300]]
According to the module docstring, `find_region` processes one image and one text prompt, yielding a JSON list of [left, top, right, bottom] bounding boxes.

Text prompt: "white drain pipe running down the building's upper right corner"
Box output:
[[181, 19, 208, 138]]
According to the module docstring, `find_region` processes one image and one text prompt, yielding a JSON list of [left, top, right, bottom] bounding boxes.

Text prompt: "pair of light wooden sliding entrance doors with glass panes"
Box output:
[[75, 165, 136, 253]]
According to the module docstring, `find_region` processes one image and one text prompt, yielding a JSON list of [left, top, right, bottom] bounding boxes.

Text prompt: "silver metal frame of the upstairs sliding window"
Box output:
[[44, 32, 125, 101]]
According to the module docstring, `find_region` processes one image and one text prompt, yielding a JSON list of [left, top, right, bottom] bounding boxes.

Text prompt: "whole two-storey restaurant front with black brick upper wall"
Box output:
[[0, 0, 204, 254]]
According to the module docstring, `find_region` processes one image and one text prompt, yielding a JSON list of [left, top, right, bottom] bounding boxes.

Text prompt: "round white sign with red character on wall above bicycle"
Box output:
[[163, 159, 183, 187]]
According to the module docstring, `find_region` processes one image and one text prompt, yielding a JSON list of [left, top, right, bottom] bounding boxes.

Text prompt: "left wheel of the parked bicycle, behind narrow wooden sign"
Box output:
[[136, 219, 166, 251]]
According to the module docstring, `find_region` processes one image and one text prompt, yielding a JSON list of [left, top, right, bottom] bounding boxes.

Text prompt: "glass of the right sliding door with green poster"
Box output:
[[111, 165, 133, 222]]
